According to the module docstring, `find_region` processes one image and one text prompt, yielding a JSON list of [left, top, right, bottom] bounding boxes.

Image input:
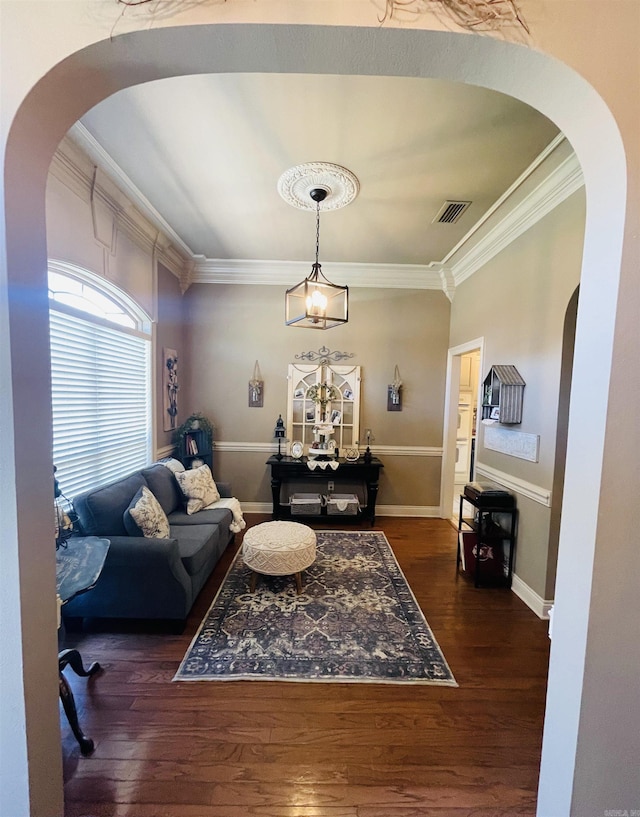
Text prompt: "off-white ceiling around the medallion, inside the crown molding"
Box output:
[[76, 74, 558, 265]]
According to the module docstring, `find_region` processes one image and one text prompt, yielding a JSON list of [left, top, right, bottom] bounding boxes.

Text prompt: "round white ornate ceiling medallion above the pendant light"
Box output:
[[278, 162, 360, 212]]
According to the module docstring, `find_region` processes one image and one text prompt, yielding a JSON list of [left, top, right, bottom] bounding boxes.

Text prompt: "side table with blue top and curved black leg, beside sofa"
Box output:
[[56, 536, 110, 755]]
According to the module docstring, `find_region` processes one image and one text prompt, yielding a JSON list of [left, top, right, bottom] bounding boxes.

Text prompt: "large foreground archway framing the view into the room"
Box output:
[[2, 24, 626, 815]]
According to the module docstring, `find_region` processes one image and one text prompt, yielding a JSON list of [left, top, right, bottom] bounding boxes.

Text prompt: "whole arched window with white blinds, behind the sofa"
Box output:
[[49, 261, 151, 497]]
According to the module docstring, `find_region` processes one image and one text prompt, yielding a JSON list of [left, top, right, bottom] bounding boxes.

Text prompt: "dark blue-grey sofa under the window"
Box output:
[[63, 463, 234, 624]]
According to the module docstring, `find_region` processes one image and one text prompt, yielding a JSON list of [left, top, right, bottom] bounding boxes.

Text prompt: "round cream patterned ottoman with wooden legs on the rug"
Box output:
[[242, 522, 316, 594]]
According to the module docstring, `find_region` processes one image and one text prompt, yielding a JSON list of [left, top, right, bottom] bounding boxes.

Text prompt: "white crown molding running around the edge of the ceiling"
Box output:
[[66, 122, 584, 294]]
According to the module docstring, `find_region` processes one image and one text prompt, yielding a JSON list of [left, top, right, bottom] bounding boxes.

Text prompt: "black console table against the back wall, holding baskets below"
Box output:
[[267, 454, 384, 526]]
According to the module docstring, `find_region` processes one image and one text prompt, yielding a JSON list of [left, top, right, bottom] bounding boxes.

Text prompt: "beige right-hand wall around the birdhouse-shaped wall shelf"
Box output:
[[450, 190, 585, 599]]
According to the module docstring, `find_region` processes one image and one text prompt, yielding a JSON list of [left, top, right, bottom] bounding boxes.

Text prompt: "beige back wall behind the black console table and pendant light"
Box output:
[[181, 284, 450, 509]]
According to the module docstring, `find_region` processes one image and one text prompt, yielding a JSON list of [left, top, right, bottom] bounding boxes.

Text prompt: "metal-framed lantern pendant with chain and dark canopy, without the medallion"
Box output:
[[285, 187, 349, 329]]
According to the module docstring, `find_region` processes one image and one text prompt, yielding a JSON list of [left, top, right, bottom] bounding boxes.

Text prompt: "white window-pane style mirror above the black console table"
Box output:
[[287, 363, 360, 455]]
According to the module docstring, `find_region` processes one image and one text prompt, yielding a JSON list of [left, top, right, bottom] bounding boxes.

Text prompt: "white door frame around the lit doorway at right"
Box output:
[[440, 337, 484, 519]]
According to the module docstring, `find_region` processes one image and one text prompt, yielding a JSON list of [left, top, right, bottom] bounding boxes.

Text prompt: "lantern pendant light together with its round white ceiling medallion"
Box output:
[[278, 162, 359, 329]]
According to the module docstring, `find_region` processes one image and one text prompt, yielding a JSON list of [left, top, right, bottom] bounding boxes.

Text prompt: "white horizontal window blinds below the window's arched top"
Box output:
[[49, 309, 151, 498]]
